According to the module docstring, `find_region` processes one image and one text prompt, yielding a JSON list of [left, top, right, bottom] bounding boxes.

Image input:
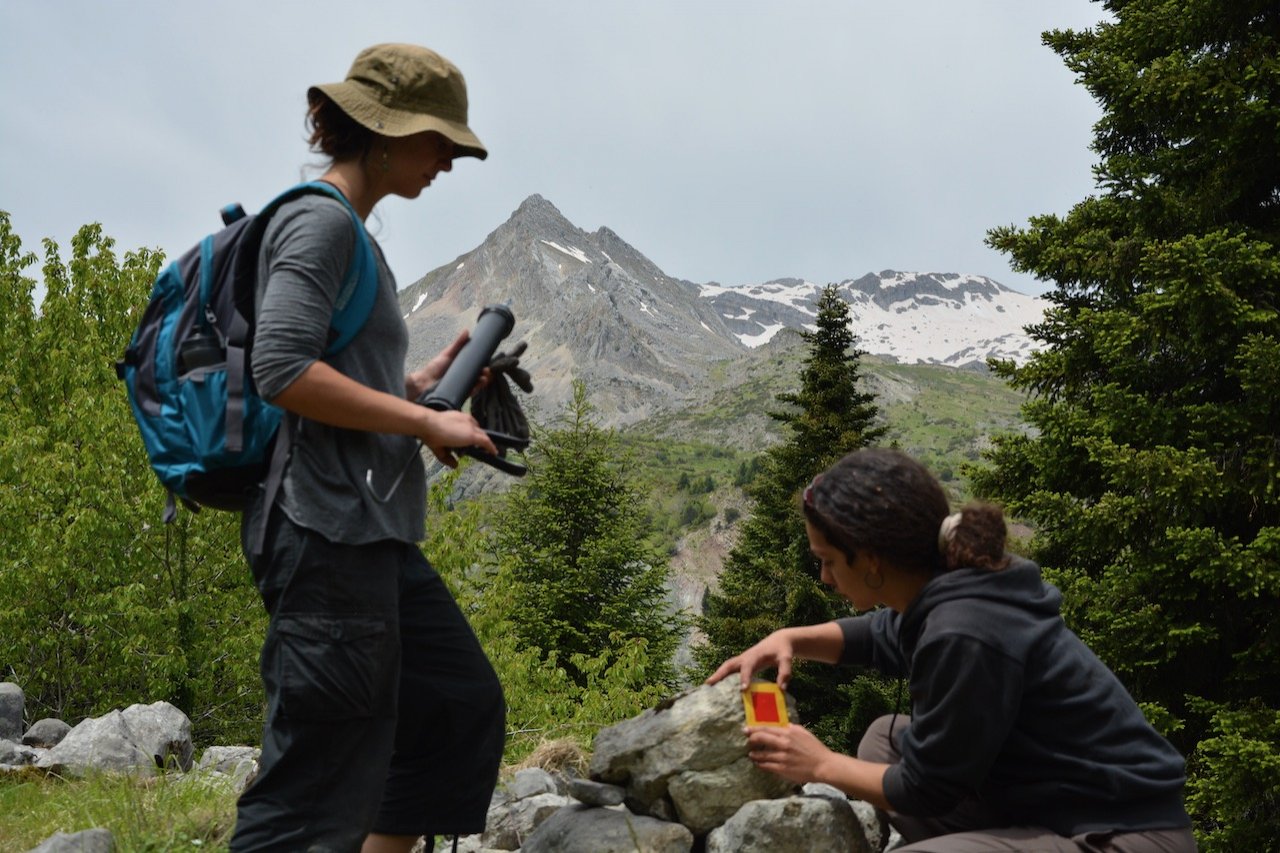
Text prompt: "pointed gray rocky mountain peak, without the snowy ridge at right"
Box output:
[[401, 195, 744, 423]]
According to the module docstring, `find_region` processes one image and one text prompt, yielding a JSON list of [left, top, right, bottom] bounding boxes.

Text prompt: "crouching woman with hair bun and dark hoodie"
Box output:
[[708, 448, 1196, 853]]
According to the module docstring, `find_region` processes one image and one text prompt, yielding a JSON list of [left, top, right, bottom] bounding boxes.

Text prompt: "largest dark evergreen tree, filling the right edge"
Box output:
[[974, 0, 1280, 850]]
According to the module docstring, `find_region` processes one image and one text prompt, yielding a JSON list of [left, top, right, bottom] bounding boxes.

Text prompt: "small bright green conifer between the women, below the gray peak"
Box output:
[[493, 383, 684, 686]]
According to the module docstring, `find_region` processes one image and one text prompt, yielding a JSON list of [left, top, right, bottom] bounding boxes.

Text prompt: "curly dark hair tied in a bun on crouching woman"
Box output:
[[801, 447, 1007, 574]]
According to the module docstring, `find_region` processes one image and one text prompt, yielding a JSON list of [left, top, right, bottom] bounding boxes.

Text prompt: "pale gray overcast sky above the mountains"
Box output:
[[0, 0, 1106, 293]]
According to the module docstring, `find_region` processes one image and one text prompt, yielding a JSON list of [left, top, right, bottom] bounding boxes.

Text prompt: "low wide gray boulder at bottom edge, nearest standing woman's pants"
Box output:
[[520, 806, 694, 853]]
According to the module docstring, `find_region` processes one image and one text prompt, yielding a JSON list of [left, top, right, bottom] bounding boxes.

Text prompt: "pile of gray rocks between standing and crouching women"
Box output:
[[458, 679, 890, 853]]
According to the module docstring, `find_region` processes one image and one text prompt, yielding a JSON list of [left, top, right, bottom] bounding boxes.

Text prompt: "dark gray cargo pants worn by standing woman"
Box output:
[[230, 507, 506, 853]]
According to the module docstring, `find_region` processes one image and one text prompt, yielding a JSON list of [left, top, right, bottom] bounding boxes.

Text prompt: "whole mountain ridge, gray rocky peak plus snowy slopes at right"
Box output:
[[399, 195, 1047, 427]]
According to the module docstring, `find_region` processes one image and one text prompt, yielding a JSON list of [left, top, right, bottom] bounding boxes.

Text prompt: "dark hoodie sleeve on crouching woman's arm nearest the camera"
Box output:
[[884, 634, 1023, 816]]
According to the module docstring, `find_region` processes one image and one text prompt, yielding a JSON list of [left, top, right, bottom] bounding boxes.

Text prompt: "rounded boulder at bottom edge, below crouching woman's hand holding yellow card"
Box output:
[[707, 797, 876, 853]]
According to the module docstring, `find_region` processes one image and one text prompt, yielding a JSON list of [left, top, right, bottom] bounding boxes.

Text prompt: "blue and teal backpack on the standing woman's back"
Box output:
[[115, 182, 378, 521]]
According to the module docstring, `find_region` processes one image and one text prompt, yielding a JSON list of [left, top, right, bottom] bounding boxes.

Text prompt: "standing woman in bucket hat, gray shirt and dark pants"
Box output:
[[230, 45, 504, 853]]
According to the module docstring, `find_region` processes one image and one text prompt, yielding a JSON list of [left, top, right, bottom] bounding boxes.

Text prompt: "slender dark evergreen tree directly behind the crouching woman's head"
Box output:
[[696, 286, 884, 751]]
